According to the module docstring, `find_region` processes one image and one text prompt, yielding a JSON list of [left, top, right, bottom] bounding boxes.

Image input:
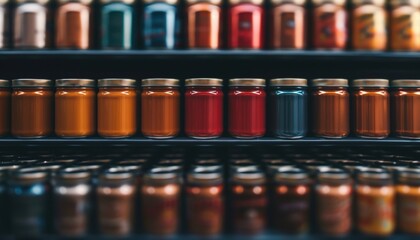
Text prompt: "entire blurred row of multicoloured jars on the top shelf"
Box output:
[[0, 0, 420, 51]]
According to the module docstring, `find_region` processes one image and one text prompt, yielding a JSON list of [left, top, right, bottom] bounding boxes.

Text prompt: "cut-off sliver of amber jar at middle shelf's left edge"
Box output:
[[0, 79, 11, 136]]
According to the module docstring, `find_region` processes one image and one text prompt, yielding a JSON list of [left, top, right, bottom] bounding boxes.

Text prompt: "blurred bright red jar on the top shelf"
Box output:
[[228, 0, 264, 49]]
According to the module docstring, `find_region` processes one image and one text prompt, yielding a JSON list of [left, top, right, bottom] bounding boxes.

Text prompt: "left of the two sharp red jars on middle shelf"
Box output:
[[185, 78, 223, 139]]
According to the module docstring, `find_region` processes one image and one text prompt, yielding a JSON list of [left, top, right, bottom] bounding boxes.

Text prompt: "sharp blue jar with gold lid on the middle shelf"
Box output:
[[269, 78, 308, 139]]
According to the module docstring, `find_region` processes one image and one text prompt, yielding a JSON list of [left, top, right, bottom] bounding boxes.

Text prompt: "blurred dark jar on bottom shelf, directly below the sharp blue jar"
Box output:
[[270, 167, 311, 234]]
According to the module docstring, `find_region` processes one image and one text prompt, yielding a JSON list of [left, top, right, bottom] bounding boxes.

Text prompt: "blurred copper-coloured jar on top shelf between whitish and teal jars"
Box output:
[[55, 0, 93, 49]]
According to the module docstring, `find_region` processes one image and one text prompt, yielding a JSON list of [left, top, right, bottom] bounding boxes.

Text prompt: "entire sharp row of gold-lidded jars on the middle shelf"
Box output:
[[0, 78, 420, 139]]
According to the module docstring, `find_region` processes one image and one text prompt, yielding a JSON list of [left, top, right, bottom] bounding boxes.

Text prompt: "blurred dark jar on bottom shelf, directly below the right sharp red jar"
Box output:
[[230, 171, 267, 235]]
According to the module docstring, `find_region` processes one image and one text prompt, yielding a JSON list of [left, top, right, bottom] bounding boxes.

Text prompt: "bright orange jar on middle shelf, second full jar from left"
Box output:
[[55, 79, 96, 138]]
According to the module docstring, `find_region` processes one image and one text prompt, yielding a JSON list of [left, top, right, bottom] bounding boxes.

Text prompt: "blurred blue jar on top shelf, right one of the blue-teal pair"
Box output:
[[143, 0, 179, 49]]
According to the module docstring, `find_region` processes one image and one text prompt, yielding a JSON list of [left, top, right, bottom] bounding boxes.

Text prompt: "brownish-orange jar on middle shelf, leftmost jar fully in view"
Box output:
[[11, 79, 53, 138]]
